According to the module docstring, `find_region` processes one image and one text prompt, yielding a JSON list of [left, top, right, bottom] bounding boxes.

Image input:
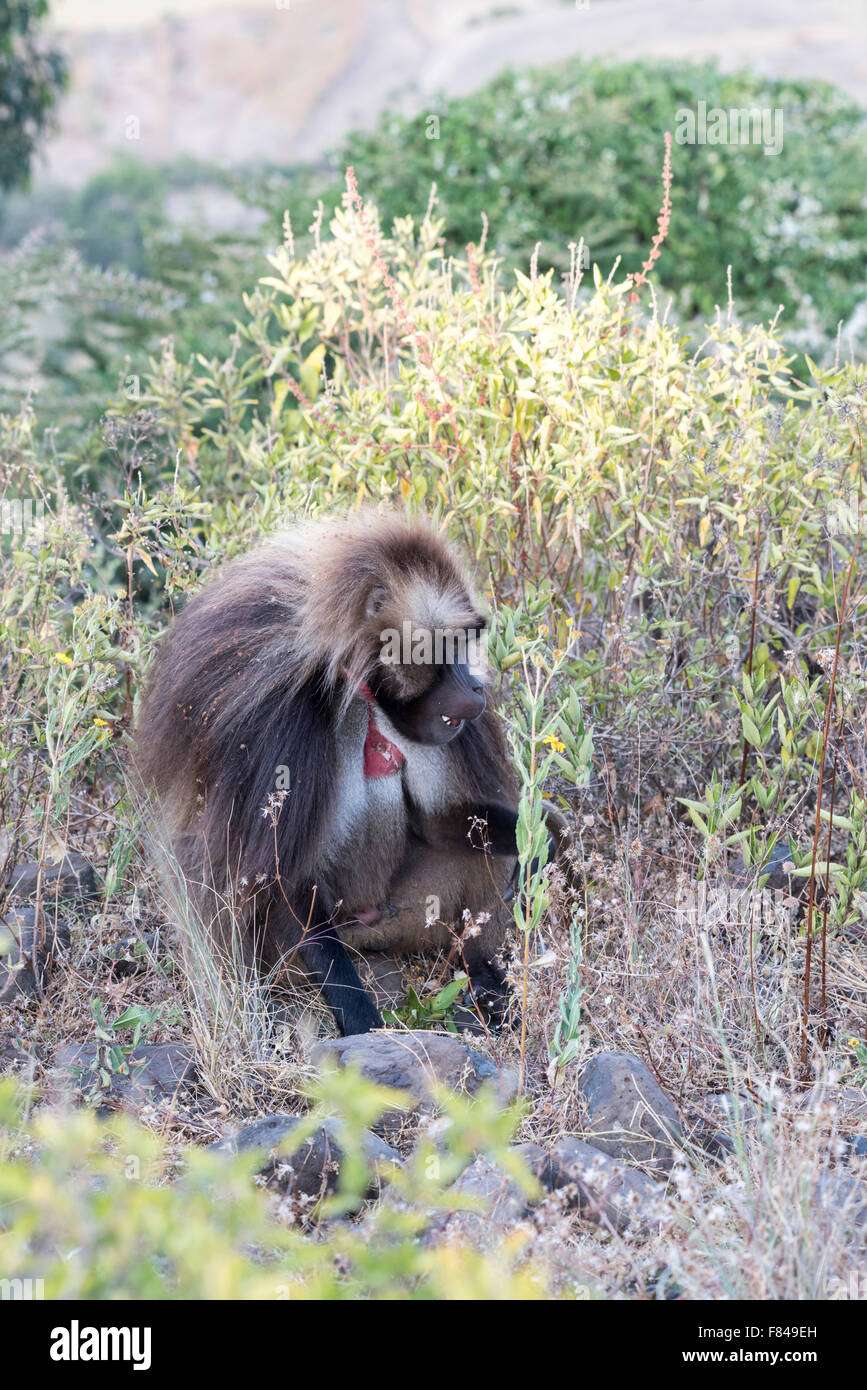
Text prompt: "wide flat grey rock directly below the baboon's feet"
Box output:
[[313, 1029, 517, 1105]]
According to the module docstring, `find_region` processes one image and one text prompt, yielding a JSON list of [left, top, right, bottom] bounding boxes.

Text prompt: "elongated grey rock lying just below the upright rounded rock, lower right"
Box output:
[[539, 1137, 666, 1232]]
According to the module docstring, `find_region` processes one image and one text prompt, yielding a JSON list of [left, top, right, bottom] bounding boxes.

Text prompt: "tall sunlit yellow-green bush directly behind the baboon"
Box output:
[[6, 179, 863, 900]]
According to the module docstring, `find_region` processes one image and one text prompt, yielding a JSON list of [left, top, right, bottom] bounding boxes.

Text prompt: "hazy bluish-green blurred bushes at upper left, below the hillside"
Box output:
[[0, 158, 268, 438]]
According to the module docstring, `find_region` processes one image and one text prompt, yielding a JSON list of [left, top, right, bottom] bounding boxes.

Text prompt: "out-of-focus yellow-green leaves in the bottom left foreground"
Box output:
[[0, 1073, 550, 1301]]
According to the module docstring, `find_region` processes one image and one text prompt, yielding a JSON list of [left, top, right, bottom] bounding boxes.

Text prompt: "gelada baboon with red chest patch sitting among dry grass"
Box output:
[[136, 513, 558, 1033]]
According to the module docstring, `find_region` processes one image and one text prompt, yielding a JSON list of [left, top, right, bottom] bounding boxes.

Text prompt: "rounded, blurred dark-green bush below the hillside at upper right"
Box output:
[[338, 61, 867, 356]]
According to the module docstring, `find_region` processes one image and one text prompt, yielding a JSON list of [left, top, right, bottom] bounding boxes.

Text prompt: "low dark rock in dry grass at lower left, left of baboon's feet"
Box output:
[[53, 1043, 196, 1105]]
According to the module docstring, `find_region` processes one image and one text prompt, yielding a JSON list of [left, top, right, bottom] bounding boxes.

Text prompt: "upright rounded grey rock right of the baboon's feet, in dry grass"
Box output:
[[578, 1052, 684, 1173]]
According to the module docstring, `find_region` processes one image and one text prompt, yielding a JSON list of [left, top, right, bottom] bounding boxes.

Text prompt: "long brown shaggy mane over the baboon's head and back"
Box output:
[[136, 512, 489, 873]]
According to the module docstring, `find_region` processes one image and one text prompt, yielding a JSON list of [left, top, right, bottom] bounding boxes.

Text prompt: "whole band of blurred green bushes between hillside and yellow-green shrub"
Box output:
[[0, 61, 867, 431]]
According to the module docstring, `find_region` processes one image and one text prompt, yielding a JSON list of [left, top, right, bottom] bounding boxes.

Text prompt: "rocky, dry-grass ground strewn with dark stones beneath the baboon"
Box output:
[[0, 828, 867, 1298]]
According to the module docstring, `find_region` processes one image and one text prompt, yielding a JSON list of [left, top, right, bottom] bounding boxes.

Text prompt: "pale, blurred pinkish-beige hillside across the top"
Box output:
[[40, 0, 867, 185]]
